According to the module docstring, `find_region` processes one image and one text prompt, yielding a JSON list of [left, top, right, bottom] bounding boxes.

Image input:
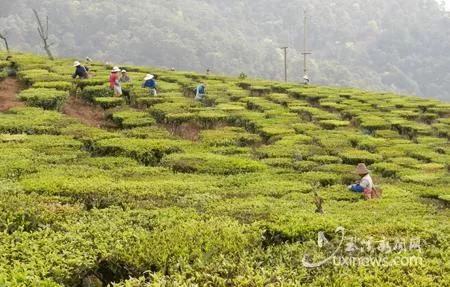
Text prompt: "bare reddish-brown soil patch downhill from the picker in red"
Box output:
[[62, 96, 116, 129]]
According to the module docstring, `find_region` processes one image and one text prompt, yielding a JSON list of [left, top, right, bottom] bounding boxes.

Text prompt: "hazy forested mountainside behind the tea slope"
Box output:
[[0, 0, 450, 101]]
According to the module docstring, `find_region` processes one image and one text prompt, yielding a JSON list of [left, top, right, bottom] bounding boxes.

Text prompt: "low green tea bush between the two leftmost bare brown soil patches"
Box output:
[[18, 88, 68, 110]]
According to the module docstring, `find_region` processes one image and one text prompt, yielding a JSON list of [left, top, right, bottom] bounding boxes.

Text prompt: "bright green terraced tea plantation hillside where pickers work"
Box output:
[[0, 53, 450, 286]]
